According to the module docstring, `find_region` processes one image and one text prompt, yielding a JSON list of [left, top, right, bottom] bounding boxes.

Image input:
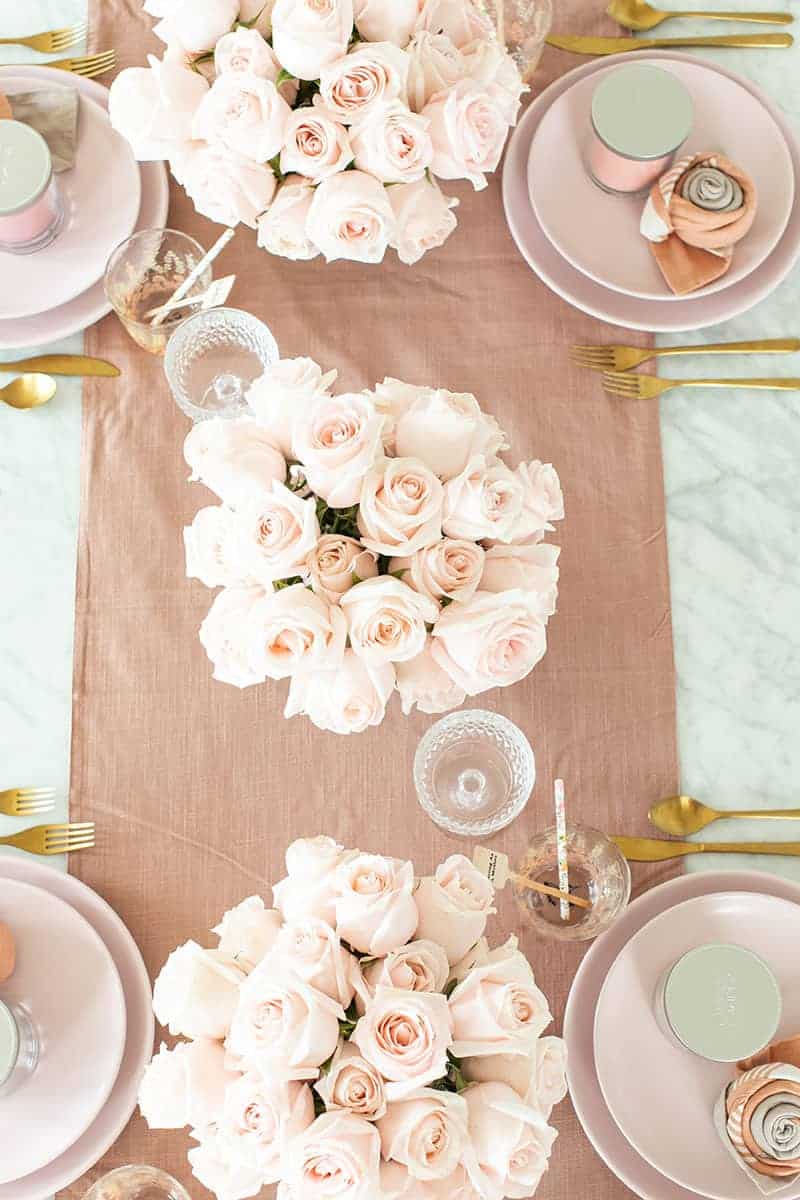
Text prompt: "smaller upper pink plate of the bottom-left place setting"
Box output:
[[0, 878, 126, 1183]]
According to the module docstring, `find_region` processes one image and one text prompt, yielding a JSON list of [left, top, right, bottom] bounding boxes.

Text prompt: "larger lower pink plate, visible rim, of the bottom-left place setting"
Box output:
[[0, 854, 154, 1200]]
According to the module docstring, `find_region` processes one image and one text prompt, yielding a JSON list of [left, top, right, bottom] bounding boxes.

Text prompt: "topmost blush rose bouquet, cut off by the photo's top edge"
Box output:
[[109, 0, 527, 264]]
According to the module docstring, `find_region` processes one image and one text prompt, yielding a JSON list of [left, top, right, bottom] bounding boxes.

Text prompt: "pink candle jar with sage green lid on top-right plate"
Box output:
[[585, 62, 693, 196]]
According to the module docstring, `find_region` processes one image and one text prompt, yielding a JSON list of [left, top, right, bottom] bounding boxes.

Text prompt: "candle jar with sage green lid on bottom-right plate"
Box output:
[[655, 942, 781, 1062]]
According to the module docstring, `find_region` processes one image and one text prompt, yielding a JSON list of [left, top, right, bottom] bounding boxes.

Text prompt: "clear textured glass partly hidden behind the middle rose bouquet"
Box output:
[[164, 308, 279, 421]]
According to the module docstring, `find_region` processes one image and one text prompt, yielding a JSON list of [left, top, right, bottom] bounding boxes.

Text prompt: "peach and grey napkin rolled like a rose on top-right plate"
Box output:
[[639, 152, 758, 295]]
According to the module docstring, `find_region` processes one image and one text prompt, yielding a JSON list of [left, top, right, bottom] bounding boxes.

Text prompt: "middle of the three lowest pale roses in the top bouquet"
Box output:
[[306, 170, 395, 263]]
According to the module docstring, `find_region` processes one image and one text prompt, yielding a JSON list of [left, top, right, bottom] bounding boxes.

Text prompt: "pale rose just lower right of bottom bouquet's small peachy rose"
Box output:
[[378, 1087, 469, 1180]]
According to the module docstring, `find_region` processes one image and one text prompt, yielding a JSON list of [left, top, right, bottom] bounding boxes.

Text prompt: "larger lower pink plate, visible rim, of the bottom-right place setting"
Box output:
[[564, 871, 800, 1200]]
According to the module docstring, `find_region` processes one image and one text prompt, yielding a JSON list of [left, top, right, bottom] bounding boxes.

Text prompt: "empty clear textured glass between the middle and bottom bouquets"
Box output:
[[414, 708, 536, 838]]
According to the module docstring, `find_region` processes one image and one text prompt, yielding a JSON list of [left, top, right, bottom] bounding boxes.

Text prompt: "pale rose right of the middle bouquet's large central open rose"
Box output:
[[441, 454, 523, 541]]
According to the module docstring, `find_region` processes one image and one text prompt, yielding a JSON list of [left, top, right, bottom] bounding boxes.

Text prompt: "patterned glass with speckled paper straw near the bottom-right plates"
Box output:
[[513, 826, 631, 942]]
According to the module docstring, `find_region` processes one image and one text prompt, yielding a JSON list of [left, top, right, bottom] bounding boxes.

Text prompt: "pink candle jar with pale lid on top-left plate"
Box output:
[[0, 121, 64, 254]]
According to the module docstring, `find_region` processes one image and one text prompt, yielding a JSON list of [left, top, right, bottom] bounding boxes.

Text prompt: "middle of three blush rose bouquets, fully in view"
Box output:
[[185, 359, 564, 733]]
